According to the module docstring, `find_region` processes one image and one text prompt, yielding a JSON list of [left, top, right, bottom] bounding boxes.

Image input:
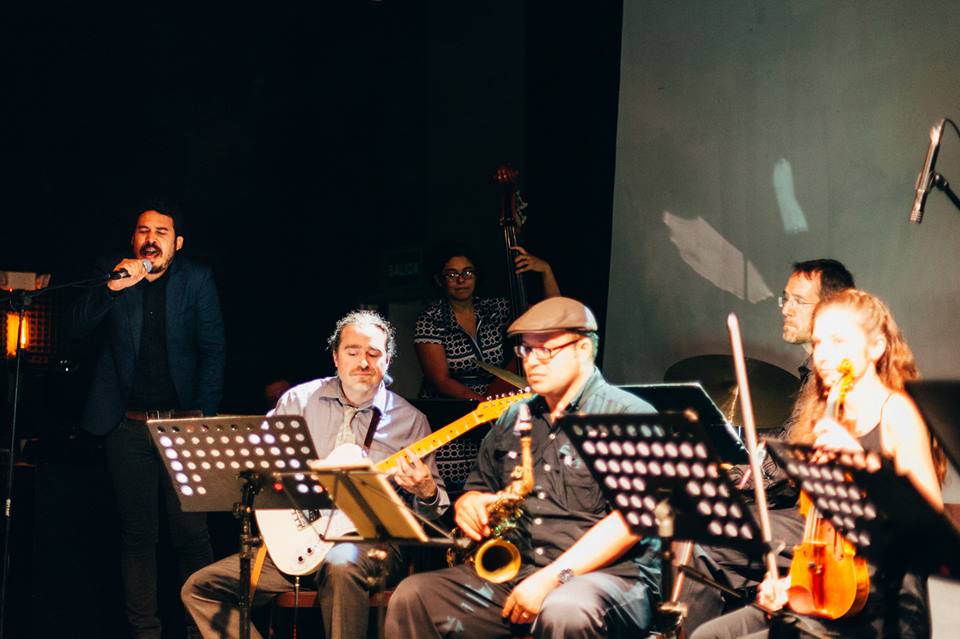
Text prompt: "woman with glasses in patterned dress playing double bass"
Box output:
[[413, 246, 560, 401]]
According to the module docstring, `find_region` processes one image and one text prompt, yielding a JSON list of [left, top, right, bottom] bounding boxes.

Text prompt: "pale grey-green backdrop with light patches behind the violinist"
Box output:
[[605, 0, 960, 382]]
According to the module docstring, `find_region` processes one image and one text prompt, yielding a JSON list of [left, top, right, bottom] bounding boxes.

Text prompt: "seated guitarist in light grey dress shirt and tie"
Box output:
[[181, 311, 450, 639]]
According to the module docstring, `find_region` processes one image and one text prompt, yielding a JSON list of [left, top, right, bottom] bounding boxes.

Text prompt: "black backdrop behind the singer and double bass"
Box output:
[[0, 0, 621, 416]]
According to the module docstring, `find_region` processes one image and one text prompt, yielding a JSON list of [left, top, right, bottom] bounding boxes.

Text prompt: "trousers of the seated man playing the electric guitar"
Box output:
[[180, 543, 402, 639]]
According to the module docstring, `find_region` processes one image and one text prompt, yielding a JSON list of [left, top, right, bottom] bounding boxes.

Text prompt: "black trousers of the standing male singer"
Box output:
[[104, 420, 213, 639]]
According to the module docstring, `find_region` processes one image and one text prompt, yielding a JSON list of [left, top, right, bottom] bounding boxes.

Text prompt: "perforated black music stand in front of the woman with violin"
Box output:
[[767, 440, 960, 577]]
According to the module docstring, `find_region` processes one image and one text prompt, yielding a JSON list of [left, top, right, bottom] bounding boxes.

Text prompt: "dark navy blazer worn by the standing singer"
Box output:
[[69, 255, 226, 435]]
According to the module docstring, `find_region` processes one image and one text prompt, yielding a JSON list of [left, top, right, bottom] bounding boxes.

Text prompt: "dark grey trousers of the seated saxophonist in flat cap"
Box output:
[[386, 565, 652, 639]]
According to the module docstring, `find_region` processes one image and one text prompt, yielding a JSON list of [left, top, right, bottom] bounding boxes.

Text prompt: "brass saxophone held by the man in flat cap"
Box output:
[[447, 404, 533, 584]]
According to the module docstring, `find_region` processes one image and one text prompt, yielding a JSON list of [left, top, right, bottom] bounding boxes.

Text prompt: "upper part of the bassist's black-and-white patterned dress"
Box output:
[[413, 297, 510, 397]]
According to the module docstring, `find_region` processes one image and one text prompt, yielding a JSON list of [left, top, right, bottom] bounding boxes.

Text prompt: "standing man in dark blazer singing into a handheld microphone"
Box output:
[[70, 202, 224, 639]]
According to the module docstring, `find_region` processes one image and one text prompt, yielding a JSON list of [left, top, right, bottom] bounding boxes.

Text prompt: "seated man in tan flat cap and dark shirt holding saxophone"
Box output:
[[386, 297, 659, 638]]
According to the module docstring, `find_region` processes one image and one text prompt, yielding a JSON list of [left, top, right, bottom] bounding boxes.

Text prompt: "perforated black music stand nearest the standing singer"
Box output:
[[147, 415, 322, 639]]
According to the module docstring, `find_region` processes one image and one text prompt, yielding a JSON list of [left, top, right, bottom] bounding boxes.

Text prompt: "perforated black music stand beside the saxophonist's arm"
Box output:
[[558, 412, 768, 636]]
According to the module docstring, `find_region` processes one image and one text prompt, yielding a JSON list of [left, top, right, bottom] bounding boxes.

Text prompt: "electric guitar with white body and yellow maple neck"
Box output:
[[255, 393, 532, 575]]
